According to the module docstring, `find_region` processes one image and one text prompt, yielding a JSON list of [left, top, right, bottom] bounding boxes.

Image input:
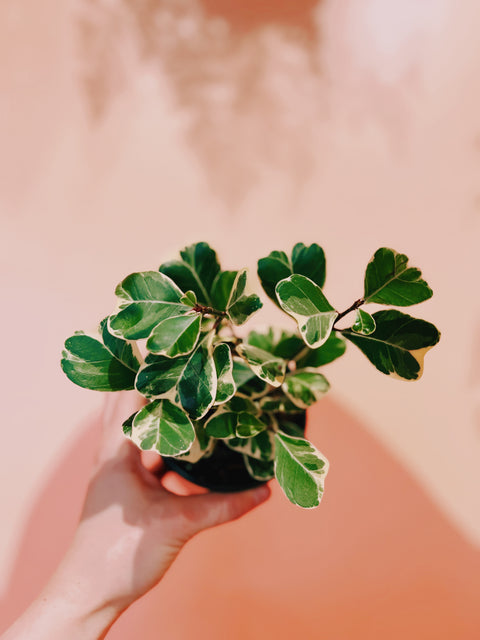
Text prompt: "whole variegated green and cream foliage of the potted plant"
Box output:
[[61, 242, 440, 507]]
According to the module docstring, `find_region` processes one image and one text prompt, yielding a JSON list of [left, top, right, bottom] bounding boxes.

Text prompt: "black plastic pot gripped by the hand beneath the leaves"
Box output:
[[160, 412, 305, 493]]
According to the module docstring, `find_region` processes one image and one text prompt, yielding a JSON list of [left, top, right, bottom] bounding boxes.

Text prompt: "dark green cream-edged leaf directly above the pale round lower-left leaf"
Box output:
[[135, 354, 189, 398]]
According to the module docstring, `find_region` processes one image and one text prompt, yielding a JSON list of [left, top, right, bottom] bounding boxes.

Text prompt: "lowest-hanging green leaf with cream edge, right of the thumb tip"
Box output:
[[275, 432, 328, 509]]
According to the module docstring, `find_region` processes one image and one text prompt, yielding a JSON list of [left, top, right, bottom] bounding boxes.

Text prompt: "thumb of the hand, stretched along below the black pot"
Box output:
[[183, 484, 271, 535]]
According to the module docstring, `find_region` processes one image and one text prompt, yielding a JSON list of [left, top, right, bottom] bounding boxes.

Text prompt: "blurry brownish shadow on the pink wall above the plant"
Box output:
[[77, 0, 325, 205]]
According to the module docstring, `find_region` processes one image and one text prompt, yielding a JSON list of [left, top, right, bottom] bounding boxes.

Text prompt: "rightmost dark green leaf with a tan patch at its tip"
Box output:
[[342, 309, 440, 380]]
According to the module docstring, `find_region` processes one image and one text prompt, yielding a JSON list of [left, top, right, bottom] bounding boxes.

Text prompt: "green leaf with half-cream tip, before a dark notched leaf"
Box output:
[[276, 274, 338, 348]]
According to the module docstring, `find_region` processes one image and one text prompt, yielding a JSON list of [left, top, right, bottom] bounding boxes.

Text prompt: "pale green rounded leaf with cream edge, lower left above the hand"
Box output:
[[127, 400, 195, 456]]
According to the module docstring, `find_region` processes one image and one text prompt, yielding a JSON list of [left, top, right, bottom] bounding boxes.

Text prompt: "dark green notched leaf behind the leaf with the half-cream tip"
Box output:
[[258, 242, 325, 305]]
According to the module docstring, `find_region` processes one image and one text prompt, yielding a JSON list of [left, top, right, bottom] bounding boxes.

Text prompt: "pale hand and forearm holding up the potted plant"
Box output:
[[0, 391, 270, 640]]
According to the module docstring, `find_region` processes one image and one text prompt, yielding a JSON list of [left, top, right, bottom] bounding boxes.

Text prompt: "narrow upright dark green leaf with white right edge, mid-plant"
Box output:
[[178, 336, 217, 420]]
